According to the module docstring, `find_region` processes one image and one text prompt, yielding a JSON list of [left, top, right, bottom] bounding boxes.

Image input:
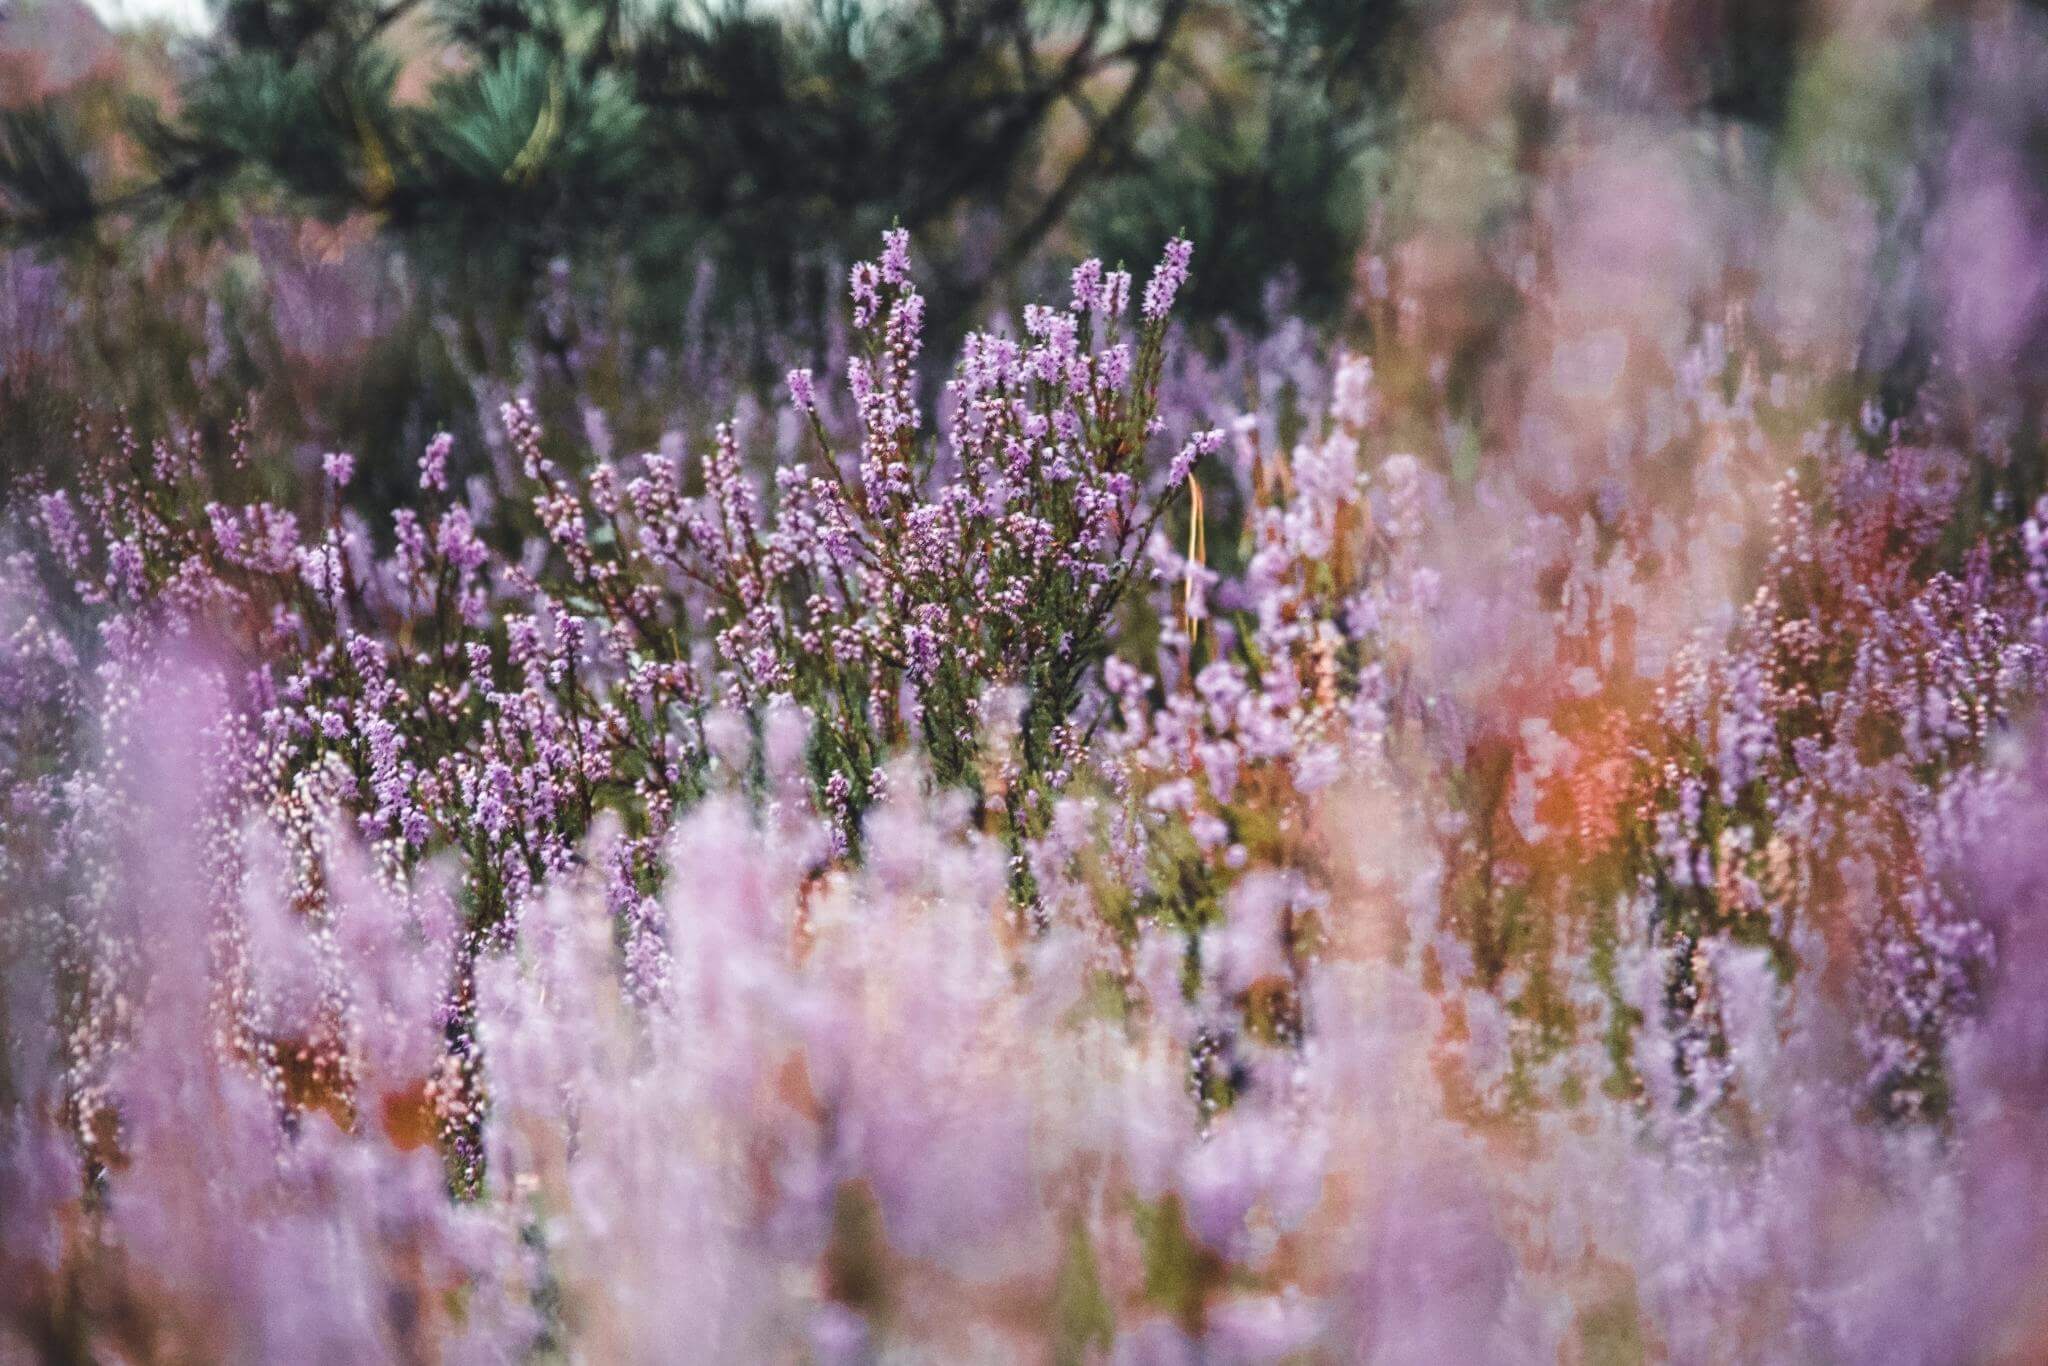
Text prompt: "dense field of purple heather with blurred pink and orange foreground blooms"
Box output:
[[12, 205, 2048, 1362]]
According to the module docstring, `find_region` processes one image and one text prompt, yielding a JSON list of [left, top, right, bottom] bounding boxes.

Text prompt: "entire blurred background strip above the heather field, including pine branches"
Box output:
[[0, 0, 2048, 496]]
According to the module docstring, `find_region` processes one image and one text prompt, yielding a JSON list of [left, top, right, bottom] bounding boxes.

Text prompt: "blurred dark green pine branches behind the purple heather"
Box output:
[[0, 0, 1405, 336]]
